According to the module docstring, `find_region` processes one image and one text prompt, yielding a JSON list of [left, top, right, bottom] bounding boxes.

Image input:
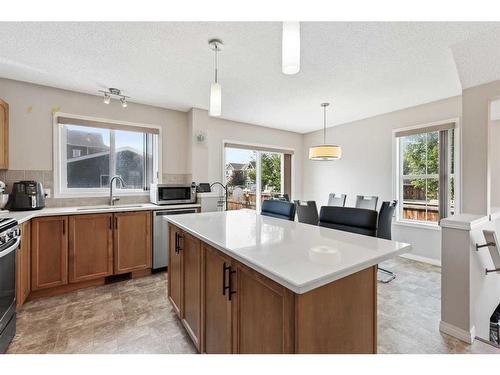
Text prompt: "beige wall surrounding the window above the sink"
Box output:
[[0, 79, 190, 174]]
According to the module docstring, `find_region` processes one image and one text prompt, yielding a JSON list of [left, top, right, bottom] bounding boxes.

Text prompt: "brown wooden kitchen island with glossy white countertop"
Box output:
[[165, 210, 411, 353]]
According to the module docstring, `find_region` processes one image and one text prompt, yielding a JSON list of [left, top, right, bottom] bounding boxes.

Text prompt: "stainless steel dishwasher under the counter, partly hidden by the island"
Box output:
[[153, 208, 198, 270]]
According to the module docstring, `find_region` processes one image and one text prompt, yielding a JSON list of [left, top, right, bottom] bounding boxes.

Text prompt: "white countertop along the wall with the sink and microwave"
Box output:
[[0, 203, 200, 224]]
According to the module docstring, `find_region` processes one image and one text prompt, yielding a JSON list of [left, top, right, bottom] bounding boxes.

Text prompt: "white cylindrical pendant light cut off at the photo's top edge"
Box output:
[[281, 22, 300, 74]]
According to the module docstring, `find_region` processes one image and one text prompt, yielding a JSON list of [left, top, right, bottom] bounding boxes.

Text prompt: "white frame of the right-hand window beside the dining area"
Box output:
[[392, 117, 462, 229]]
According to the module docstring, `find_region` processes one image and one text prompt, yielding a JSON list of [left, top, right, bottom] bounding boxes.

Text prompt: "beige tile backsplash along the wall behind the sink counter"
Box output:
[[0, 170, 191, 207]]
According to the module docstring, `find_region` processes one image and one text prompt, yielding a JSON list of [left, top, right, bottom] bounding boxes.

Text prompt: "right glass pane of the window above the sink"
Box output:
[[114, 130, 146, 189]]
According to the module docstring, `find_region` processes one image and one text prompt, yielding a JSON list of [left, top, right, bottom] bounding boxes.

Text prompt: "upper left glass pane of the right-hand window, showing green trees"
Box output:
[[399, 133, 427, 176]]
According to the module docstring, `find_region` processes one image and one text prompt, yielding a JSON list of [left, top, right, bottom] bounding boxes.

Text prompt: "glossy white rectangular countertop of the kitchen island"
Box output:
[[164, 210, 411, 294]]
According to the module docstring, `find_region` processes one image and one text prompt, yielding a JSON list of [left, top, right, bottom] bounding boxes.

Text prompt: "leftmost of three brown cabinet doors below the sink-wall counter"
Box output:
[[31, 216, 68, 291]]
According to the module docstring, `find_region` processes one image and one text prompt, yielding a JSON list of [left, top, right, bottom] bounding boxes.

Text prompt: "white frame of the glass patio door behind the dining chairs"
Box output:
[[221, 139, 295, 213]]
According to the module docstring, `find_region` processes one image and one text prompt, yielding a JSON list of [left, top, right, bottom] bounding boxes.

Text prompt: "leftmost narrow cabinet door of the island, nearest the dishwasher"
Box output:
[[168, 224, 182, 317]]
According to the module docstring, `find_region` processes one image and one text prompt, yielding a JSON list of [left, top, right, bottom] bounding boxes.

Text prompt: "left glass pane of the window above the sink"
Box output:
[[63, 125, 110, 188]]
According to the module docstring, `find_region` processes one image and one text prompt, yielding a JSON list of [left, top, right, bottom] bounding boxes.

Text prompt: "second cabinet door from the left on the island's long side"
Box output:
[[180, 233, 201, 350]]
